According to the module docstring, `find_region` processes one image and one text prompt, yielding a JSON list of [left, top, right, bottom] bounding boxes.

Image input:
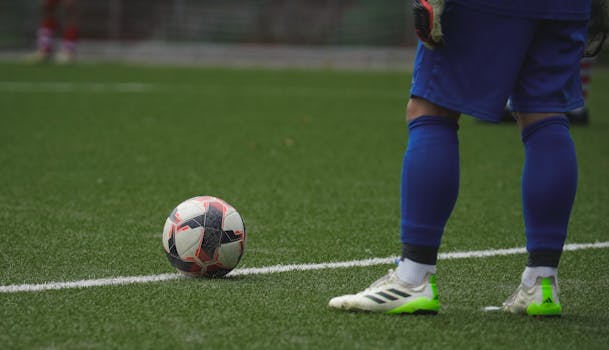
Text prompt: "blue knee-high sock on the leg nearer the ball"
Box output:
[[401, 116, 459, 250]]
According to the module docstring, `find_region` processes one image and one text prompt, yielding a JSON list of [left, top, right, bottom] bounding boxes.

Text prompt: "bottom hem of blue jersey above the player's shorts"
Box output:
[[447, 0, 591, 20]]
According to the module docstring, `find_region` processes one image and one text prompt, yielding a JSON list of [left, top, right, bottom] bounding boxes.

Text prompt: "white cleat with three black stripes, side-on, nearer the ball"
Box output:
[[328, 270, 440, 314]]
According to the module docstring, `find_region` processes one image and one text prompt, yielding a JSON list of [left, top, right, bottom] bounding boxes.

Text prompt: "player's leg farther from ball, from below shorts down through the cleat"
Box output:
[[503, 113, 577, 316]]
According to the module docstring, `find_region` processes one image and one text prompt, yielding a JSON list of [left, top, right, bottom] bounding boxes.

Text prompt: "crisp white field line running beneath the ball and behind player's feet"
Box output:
[[0, 242, 609, 293]]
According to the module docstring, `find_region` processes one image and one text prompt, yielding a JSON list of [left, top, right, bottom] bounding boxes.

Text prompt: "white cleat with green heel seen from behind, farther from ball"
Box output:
[[503, 277, 562, 317]]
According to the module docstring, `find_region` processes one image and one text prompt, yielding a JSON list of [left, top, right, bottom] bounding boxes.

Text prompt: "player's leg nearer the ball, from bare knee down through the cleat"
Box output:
[[329, 97, 459, 314]]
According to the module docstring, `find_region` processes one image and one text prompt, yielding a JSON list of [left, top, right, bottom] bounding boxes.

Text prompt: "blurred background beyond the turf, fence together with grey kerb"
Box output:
[[0, 0, 416, 69]]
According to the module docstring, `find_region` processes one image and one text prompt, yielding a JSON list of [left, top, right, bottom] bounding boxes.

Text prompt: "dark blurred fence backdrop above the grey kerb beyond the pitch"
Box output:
[[0, 0, 415, 47]]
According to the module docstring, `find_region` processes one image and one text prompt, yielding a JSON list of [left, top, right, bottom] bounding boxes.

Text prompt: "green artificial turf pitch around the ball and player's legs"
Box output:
[[0, 63, 609, 349]]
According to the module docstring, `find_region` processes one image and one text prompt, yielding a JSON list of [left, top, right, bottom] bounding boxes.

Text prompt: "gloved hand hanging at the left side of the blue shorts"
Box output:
[[412, 0, 444, 49]]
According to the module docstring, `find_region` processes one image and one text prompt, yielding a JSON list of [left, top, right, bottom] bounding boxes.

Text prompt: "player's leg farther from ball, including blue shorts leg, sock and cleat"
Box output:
[[503, 21, 586, 316]]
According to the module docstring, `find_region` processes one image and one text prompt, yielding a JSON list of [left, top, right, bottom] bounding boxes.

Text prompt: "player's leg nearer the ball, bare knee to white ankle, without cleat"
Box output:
[[397, 96, 460, 307]]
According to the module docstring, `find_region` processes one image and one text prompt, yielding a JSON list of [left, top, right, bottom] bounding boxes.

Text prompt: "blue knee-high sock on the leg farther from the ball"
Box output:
[[522, 116, 577, 256]]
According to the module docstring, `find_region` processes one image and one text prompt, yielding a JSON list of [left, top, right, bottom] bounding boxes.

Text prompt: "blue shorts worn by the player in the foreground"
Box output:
[[410, 3, 587, 122]]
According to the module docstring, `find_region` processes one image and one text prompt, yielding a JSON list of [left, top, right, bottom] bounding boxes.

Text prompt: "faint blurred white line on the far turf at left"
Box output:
[[0, 81, 154, 93]]
